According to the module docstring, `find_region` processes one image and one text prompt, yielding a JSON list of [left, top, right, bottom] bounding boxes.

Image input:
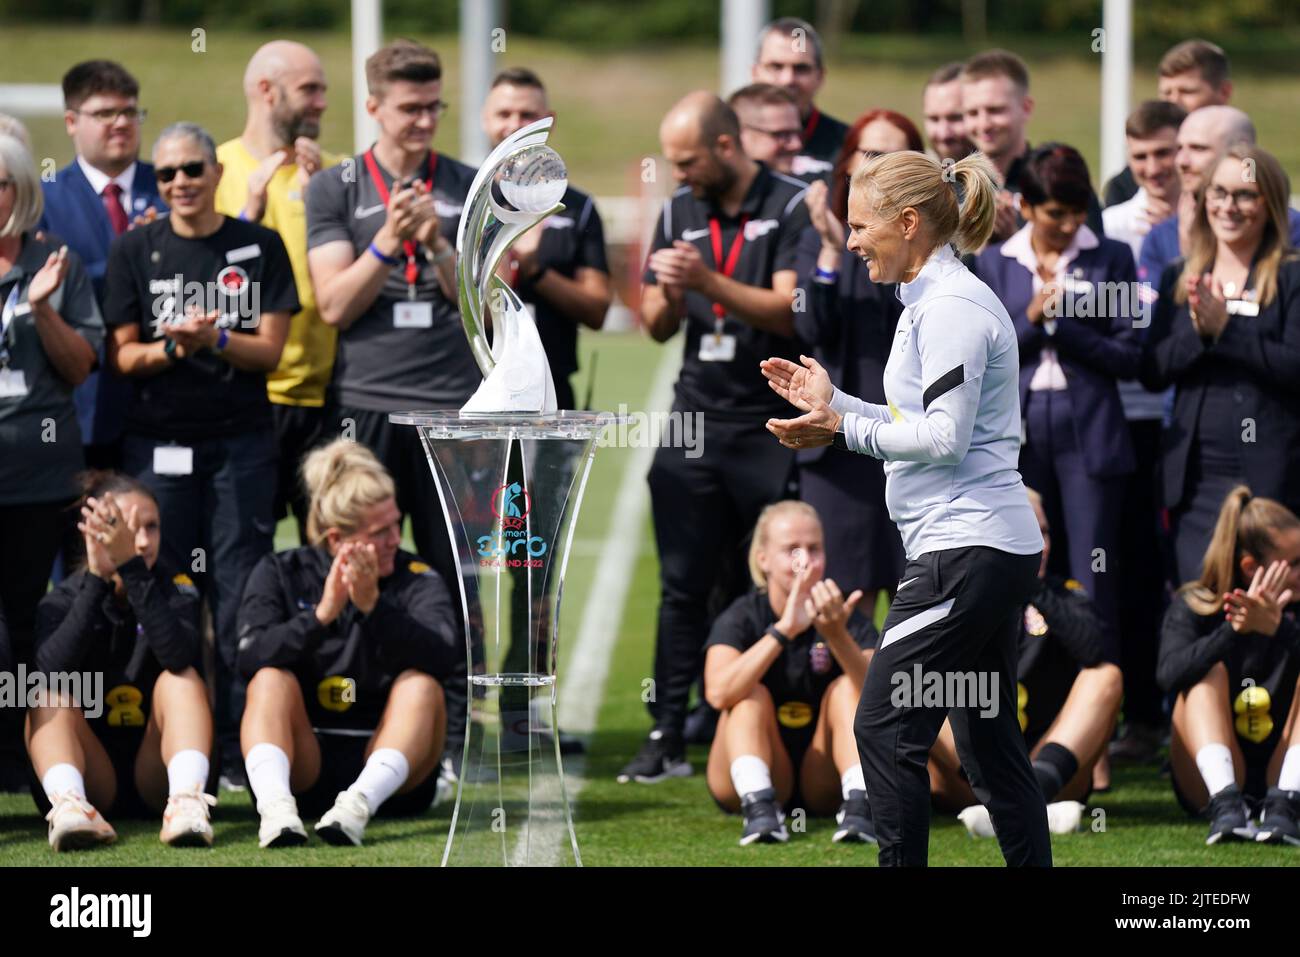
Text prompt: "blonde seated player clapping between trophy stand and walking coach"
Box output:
[[705, 501, 876, 844]]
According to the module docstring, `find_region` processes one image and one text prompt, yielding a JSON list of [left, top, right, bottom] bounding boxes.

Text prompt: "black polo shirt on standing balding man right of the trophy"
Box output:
[[642, 164, 809, 426]]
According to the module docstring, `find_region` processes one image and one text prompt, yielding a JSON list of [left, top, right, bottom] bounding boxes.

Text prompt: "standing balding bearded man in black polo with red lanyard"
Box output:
[[619, 91, 809, 783]]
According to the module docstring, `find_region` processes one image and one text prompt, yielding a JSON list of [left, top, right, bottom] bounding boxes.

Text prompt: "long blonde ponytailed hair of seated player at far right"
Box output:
[[1179, 485, 1300, 615]]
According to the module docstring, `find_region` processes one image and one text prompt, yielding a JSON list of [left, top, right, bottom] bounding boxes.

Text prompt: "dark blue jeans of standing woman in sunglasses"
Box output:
[[122, 428, 278, 758]]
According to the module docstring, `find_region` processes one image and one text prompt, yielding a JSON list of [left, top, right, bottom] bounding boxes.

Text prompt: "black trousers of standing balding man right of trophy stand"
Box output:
[[646, 416, 794, 735]]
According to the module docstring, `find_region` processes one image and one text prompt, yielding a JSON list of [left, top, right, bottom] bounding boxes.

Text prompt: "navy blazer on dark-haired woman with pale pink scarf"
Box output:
[[975, 237, 1141, 479]]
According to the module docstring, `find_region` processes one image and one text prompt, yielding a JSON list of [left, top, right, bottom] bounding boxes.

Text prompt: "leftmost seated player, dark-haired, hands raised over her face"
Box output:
[[26, 472, 217, 850]]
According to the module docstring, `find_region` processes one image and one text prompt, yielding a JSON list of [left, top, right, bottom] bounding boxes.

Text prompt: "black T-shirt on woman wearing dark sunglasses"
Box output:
[[104, 216, 299, 442]]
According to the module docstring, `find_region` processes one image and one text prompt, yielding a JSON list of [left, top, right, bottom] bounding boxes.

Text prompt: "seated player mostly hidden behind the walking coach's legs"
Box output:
[[930, 489, 1123, 837]]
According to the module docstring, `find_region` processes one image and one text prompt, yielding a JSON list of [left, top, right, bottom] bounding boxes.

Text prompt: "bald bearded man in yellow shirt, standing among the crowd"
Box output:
[[217, 40, 341, 553]]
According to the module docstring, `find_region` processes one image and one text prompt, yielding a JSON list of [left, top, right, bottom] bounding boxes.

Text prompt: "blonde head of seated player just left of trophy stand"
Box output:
[[303, 438, 397, 545]]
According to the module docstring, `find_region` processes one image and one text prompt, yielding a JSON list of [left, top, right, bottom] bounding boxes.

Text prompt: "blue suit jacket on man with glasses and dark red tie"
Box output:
[[39, 160, 168, 445]]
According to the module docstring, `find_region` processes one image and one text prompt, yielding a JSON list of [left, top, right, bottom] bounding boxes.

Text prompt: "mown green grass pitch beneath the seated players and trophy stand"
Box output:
[[0, 333, 1300, 866]]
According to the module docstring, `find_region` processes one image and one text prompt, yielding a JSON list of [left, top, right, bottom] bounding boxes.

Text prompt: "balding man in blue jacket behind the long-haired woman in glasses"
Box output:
[[1138, 105, 1300, 289]]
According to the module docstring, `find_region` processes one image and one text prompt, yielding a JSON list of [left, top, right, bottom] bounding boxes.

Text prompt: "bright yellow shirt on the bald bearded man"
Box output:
[[217, 137, 343, 407]]
